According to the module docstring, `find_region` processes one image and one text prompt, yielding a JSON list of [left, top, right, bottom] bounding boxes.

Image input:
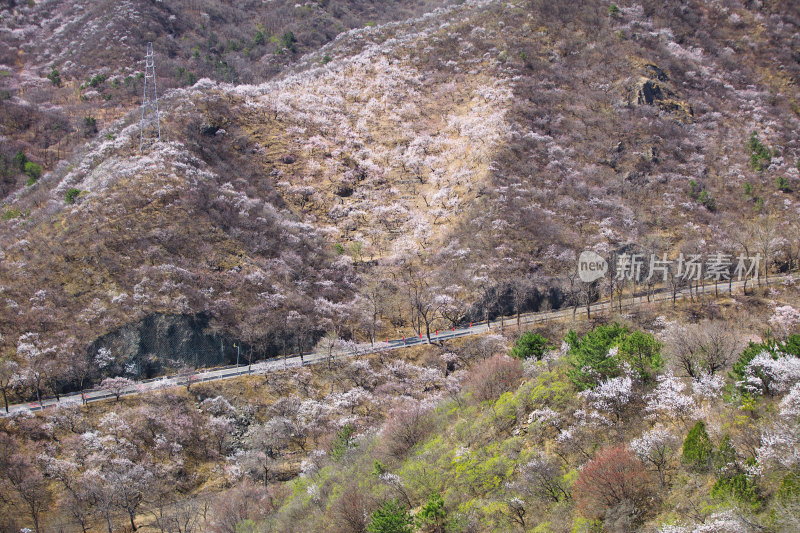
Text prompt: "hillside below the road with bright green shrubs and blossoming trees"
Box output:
[[0, 281, 800, 533]]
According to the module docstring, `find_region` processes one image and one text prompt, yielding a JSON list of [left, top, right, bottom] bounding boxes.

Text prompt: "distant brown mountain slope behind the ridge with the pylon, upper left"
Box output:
[[0, 0, 456, 197]]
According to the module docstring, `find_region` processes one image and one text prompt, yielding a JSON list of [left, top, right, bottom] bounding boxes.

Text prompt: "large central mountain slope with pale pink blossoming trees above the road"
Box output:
[[0, 1, 800, 388]]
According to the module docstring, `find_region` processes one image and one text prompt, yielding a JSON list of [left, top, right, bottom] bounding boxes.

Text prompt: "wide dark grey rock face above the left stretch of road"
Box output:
[[87, 314, 247, 378]]
